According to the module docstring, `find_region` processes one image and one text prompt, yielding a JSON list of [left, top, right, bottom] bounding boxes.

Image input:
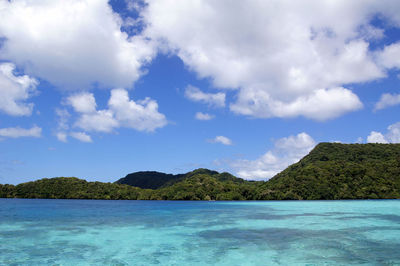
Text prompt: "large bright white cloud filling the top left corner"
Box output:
[[0, 0, 156, 89]]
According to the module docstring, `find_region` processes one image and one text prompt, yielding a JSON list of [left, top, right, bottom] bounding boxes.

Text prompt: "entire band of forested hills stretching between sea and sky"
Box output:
[[0, 143, 400, 200]]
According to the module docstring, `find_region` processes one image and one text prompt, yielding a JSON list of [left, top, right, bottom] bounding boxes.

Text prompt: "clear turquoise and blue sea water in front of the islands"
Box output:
[[0, 199, 400, 265]]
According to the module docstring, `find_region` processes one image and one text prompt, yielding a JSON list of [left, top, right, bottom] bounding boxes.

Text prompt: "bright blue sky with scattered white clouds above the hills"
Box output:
[[0, 0, 400, 184]]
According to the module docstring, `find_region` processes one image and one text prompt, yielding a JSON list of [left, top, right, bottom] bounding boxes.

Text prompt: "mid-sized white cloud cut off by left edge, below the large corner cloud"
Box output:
[[0, 63, 38, 116]]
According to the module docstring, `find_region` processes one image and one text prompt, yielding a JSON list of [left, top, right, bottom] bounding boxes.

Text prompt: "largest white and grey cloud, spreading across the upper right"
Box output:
[[142, 0, 400, 120]]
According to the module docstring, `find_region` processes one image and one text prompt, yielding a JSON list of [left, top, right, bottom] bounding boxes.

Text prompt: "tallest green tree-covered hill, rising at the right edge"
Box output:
[[257, 143, 400, 199]]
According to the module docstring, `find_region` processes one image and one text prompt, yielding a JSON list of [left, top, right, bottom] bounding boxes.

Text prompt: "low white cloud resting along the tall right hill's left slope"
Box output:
[[231, 132, 316, 180]]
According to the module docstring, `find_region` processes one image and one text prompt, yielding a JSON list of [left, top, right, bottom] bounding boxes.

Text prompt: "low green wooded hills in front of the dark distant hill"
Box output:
[[0, 174, 256, 200]]
